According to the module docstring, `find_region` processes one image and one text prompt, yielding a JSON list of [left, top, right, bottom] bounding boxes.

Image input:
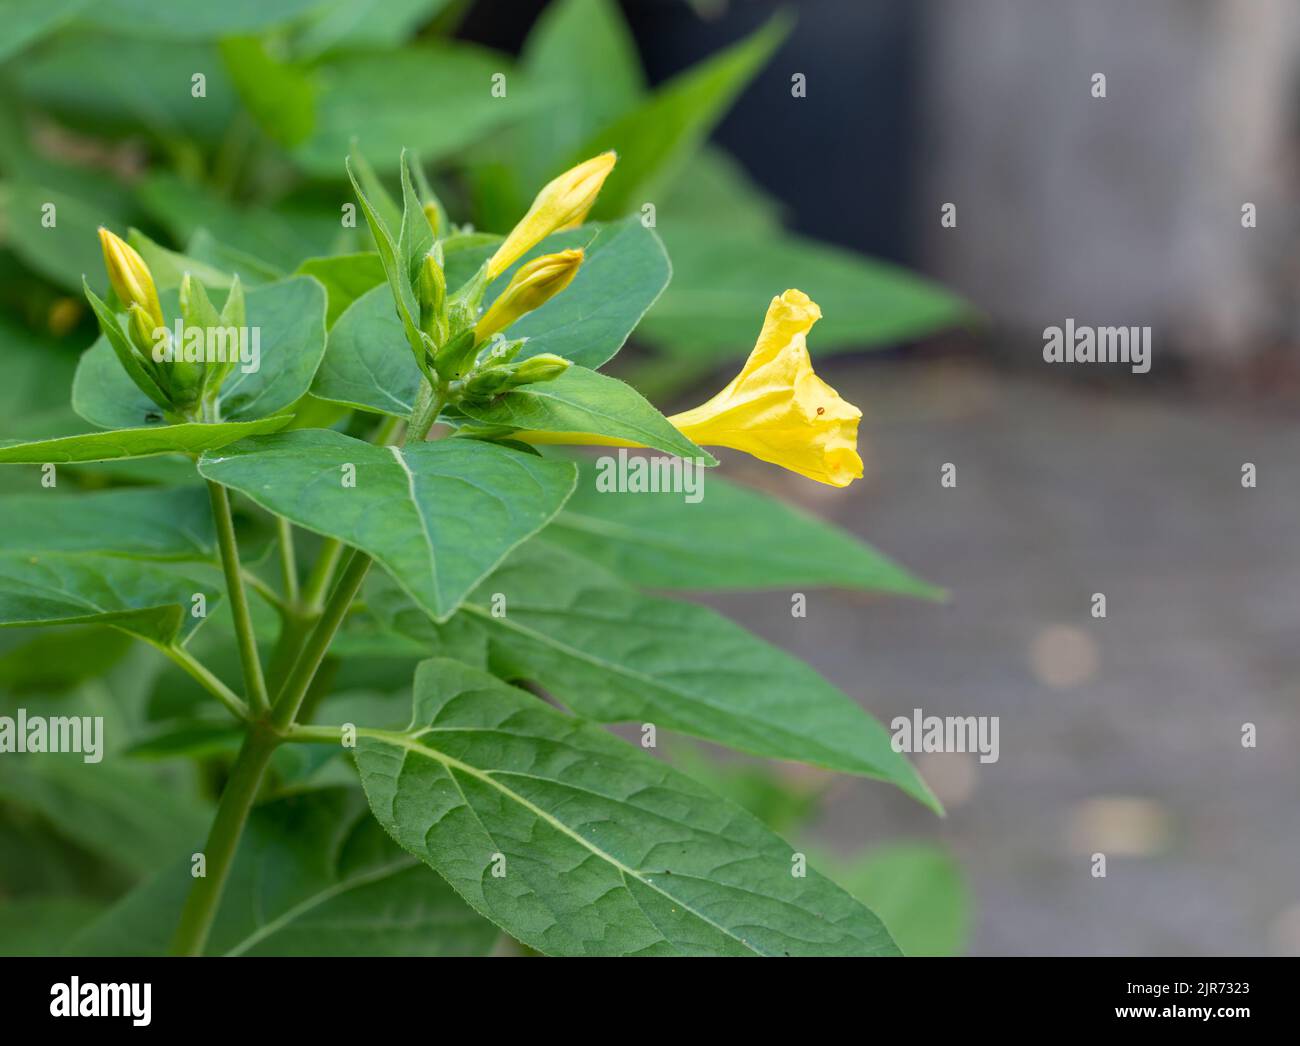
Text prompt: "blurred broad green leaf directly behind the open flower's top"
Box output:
[[641, 225, 972, 363]]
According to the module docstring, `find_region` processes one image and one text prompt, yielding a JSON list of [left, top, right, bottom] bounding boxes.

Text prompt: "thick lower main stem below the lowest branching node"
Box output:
[[172, 728, 280, 955]]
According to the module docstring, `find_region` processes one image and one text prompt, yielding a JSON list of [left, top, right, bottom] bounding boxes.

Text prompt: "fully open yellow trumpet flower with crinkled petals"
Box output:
[[515, 291, 862, 487]]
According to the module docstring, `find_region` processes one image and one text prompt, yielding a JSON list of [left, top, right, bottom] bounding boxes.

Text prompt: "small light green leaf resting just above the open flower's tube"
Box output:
[[460, 366, 717, 462]]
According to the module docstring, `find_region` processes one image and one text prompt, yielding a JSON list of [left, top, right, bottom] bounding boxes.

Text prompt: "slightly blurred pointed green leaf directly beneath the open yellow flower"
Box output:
[[546, 459, 943, 599]]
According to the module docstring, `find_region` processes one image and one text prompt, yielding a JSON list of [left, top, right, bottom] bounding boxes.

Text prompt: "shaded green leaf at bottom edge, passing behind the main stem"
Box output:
[[66, 789, 498, 956]]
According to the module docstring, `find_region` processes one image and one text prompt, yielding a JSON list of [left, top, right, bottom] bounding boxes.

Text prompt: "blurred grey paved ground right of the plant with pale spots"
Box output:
[[696, 363, 1300, 955]]
